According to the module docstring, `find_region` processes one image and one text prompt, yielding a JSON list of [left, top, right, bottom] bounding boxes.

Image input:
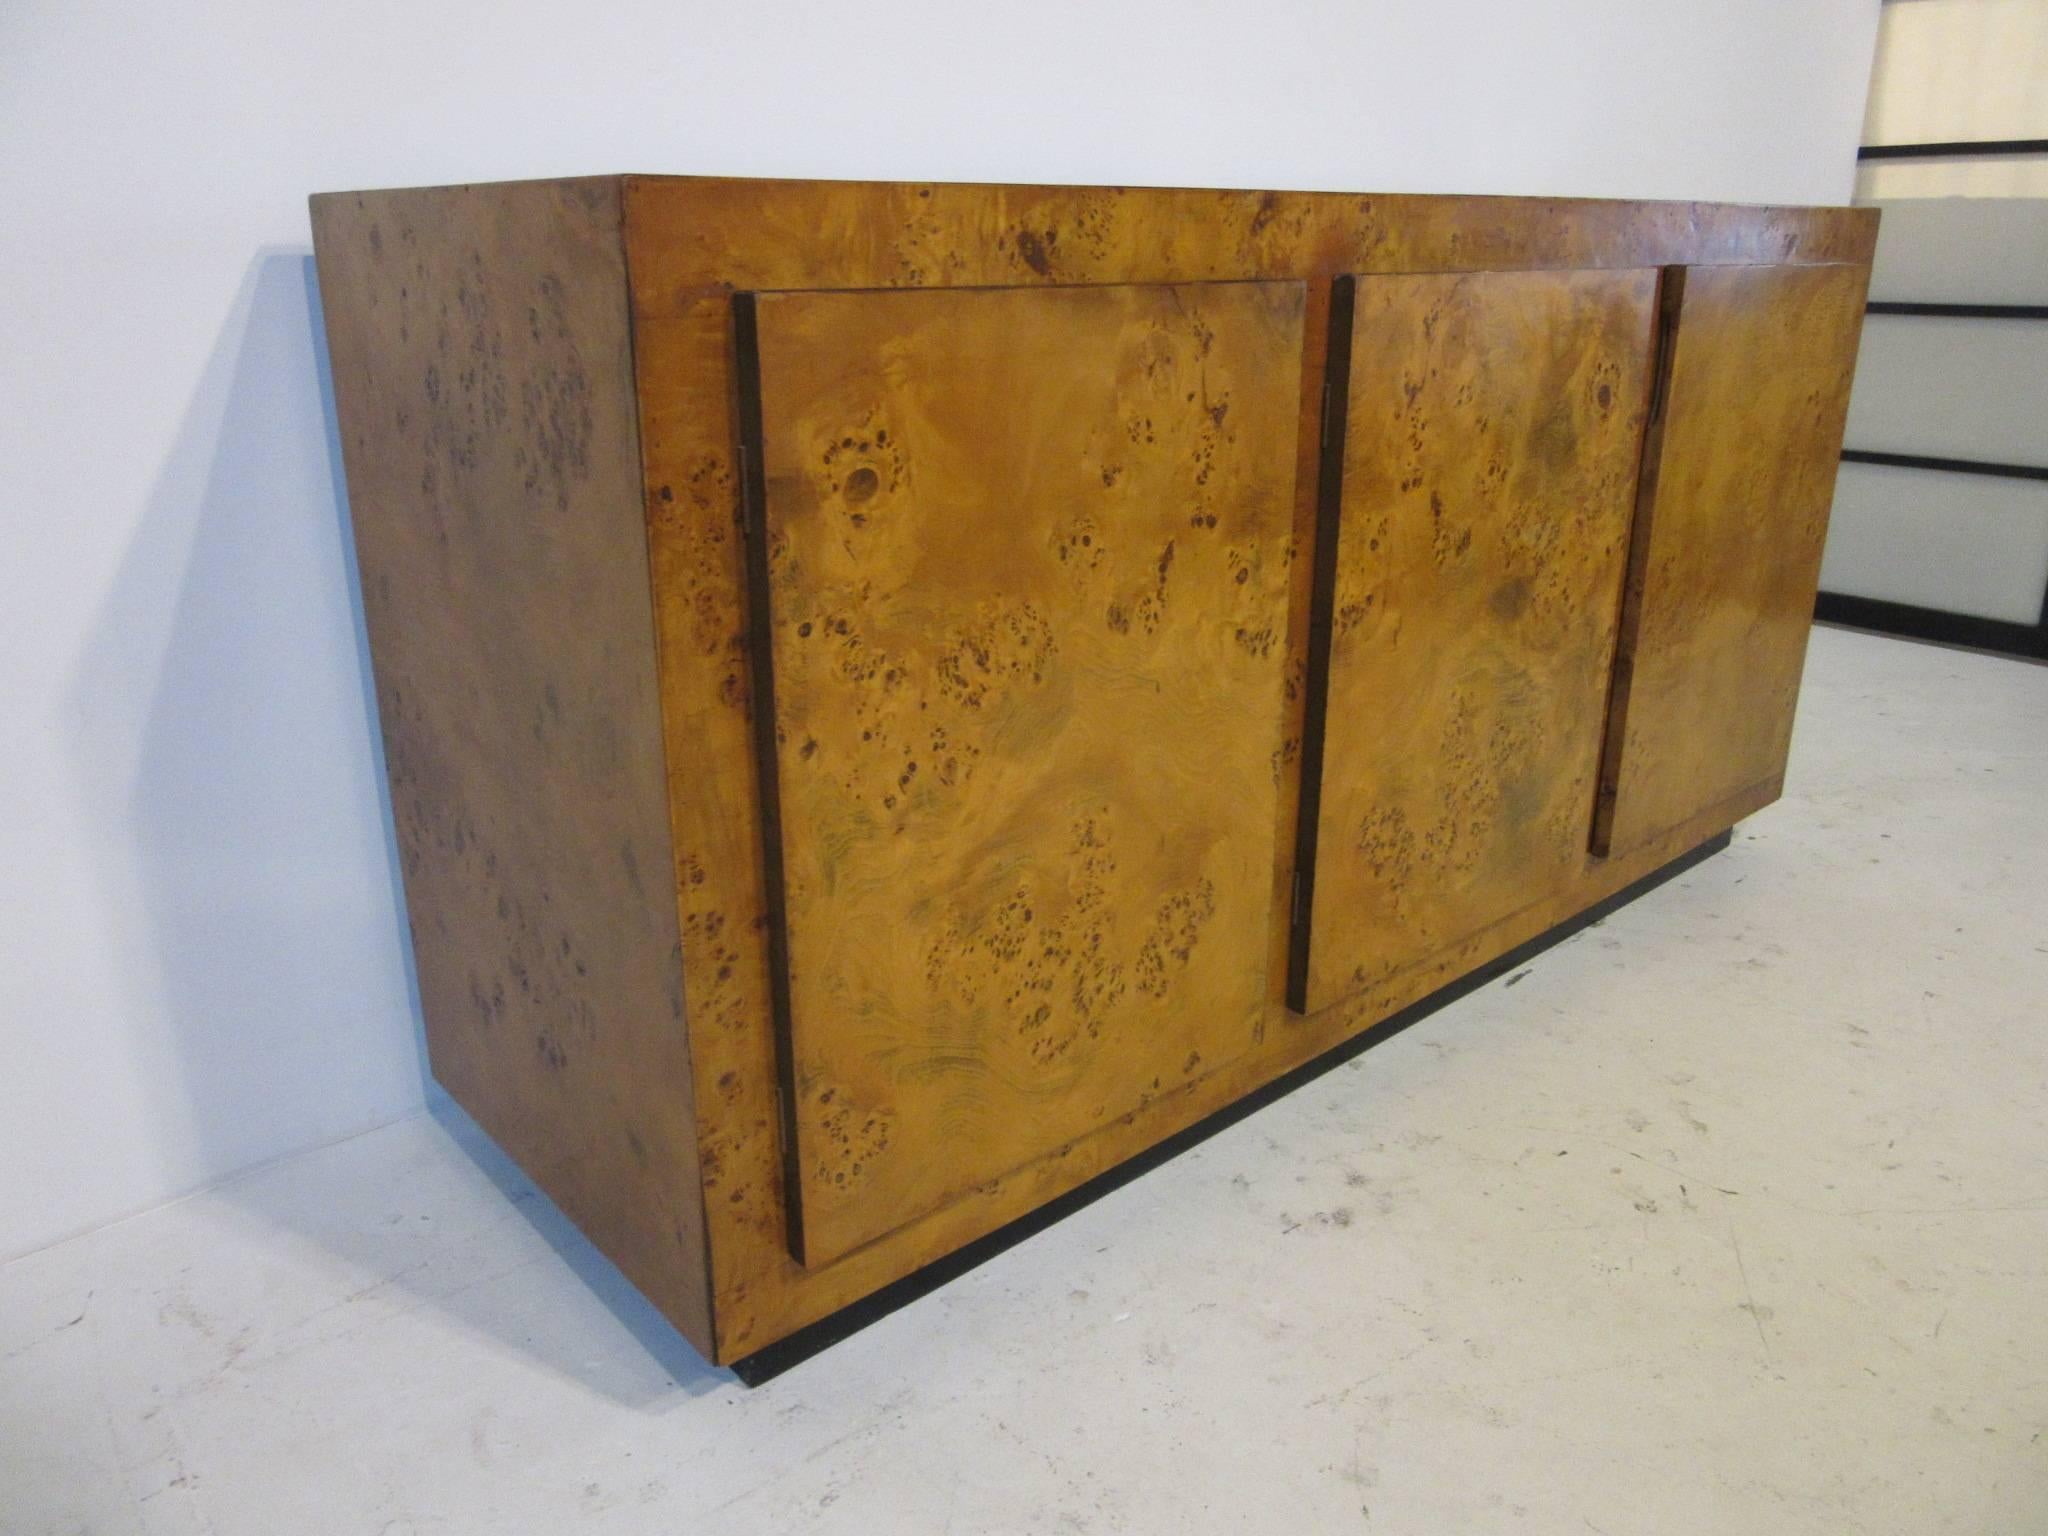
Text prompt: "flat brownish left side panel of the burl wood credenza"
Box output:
[[313, 178, 717, 1354]]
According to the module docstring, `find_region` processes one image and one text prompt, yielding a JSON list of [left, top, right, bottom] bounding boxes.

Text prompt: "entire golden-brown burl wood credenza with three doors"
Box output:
[[313, 176, 1876, 1364]]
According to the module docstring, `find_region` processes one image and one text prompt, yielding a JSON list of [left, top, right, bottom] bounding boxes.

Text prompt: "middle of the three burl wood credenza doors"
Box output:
[[1288, 268, 1657, 1012]]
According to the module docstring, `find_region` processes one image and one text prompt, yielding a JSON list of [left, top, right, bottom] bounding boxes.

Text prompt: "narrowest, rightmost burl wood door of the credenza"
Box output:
[[1593, 266, 1868, 854]]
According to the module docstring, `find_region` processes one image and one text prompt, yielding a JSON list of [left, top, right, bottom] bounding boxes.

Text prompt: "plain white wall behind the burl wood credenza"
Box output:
[[0, 0, 1876, 1255]]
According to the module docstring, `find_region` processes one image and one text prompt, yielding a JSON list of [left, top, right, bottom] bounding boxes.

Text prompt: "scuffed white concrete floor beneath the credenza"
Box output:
[[0, 631, 2048, 1536]]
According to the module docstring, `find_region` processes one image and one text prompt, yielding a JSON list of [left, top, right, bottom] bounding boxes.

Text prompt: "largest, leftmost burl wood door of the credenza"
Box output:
[[735, 283, 1305, 1264]]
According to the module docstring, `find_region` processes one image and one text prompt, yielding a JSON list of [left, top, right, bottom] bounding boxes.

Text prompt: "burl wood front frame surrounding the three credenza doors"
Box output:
[[625, 176, 1876, 1360]]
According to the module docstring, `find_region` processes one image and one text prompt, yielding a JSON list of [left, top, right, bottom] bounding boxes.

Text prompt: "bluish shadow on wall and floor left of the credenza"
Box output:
[[74, 250, 727, 1407]]
